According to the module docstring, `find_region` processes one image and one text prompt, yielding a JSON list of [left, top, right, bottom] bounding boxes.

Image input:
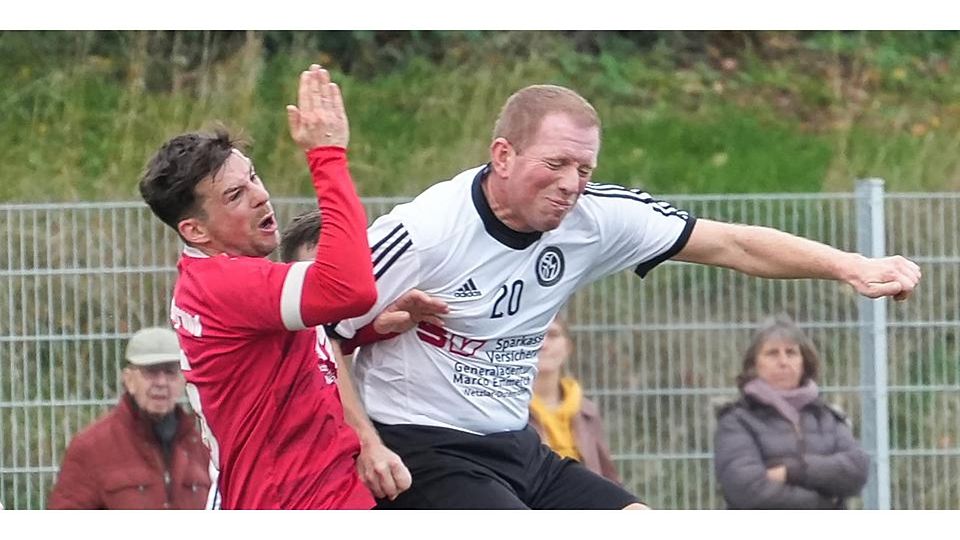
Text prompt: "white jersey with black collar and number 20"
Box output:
[[336, 166, 695, 434]]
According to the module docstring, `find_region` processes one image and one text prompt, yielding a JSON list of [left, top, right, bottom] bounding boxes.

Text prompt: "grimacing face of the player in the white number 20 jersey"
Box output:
[[507, 114, 600, 232]]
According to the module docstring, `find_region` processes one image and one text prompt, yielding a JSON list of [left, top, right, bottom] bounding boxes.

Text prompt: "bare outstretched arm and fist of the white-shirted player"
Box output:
[[674, 219, 921, 300]]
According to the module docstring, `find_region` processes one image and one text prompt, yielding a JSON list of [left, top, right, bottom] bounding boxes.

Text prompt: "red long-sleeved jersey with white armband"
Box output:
[[171, 148, 376, 509]]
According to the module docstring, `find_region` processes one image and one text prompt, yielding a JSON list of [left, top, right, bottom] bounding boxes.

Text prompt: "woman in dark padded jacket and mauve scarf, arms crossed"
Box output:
[[714, 318, 869, 509]]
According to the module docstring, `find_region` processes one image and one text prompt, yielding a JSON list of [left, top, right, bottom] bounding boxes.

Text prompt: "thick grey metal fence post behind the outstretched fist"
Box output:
[[856, 178, 890, 510]]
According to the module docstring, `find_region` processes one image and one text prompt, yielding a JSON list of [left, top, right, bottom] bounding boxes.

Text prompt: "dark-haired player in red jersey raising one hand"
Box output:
[[140, 65, 377, 509]]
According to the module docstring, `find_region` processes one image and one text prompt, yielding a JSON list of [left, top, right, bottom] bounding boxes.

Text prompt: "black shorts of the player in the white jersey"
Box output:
[[374, 422, 639, 510]]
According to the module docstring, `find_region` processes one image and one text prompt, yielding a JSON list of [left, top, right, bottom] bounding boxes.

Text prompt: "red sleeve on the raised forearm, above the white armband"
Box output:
[[300, 146, 377, 326]]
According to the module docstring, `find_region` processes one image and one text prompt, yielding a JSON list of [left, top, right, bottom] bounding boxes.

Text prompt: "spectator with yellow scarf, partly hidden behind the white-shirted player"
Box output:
[[530, 317, 620, 483]]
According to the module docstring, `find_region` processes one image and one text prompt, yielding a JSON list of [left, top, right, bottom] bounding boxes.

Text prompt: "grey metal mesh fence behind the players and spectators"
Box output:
[[0, 194, 960, 508]]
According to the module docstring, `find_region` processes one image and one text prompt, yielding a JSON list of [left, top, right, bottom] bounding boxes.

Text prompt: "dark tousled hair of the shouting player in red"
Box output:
[[139, 128, 243, 234]]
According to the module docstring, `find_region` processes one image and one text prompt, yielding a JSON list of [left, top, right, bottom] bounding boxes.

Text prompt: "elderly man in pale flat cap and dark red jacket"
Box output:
[[48, 328, 210, 510]]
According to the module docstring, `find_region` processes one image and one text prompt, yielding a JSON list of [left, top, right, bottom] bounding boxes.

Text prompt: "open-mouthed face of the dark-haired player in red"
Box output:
[[189, 150, 280, 257]]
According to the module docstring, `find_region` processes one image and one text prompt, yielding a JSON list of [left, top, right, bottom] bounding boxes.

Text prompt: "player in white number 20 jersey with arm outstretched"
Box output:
[[336, 85, 920, 509]]
